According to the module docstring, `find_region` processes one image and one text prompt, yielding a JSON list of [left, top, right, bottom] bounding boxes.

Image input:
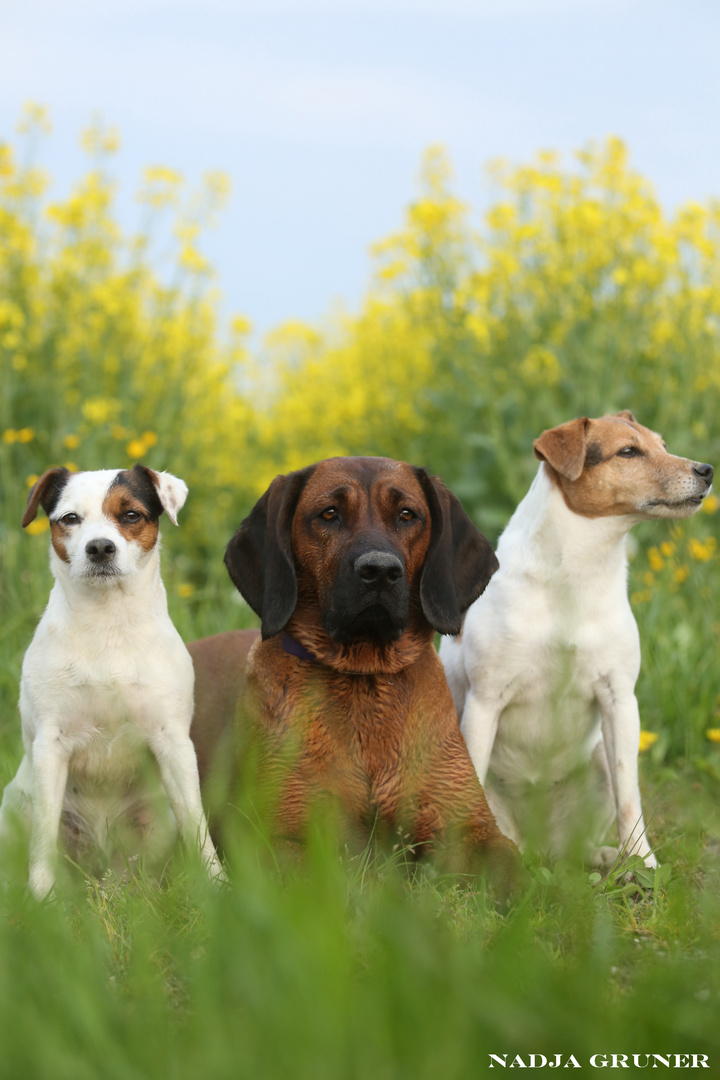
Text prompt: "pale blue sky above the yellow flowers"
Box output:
[[0, 0, 720, 330]]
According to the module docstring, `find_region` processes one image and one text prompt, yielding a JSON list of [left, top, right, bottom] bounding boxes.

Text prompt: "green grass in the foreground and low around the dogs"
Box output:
[[0, 541, 720, 1080]]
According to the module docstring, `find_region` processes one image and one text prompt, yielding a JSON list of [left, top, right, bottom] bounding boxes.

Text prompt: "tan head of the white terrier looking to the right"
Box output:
[[534, 411, 714, 518]]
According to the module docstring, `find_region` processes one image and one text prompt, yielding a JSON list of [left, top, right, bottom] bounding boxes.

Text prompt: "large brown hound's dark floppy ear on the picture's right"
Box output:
[[416, 469, 499, 634]]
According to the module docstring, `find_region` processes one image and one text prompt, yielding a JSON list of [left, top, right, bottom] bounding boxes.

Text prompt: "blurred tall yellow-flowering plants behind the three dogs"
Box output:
[[0, 106, 720, 758]]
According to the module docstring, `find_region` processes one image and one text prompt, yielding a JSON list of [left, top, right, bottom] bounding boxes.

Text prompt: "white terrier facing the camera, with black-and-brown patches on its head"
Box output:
[[0, 464, 222, 899]]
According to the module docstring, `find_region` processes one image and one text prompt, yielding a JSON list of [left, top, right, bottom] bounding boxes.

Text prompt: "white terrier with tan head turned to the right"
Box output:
[[440, 411, 712, 868]]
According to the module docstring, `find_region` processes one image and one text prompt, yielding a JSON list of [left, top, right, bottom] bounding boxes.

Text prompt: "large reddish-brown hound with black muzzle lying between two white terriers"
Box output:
[[190, 458, 515, 869]]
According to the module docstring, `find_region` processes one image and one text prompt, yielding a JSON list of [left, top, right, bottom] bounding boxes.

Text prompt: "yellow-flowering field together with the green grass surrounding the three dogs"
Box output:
[[0, 107, 720, 1080]]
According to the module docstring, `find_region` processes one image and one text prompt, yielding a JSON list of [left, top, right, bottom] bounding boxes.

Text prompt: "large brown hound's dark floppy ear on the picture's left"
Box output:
[[225, 465, 314, 639]]
